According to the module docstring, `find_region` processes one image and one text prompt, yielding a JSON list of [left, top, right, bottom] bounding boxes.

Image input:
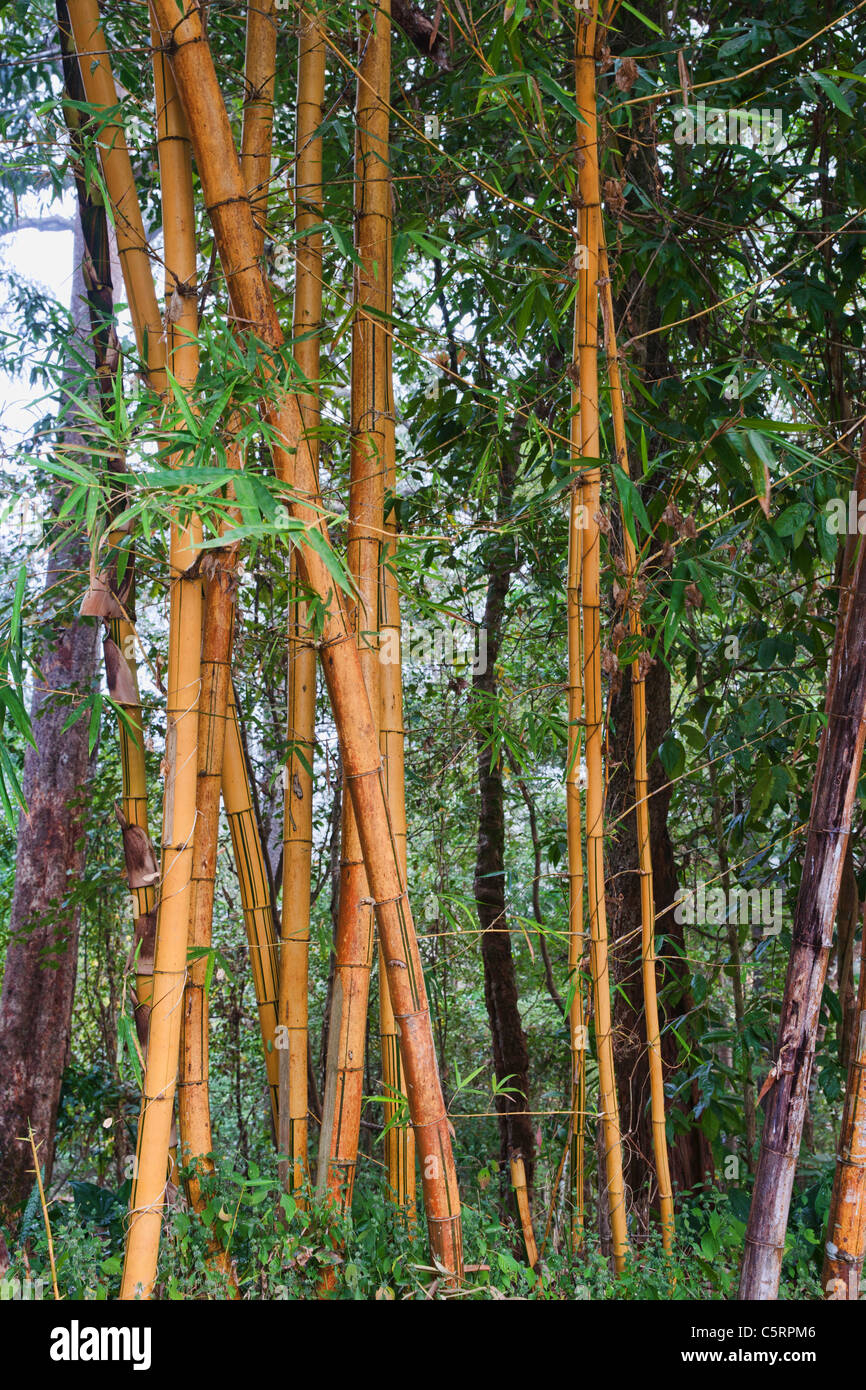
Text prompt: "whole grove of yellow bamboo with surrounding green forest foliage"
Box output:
[[0, 0, 866, 1300]]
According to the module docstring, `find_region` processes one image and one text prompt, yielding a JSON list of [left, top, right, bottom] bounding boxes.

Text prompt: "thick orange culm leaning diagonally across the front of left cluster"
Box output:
[[148, 0, 461, 1273]]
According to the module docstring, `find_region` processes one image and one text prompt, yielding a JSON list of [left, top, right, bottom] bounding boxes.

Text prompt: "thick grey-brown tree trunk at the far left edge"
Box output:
[[0, 214, 97, 1216]]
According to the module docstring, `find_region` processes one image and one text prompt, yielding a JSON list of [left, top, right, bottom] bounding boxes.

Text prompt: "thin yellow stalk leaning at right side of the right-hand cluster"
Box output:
[[599, 230, 674, 1251]]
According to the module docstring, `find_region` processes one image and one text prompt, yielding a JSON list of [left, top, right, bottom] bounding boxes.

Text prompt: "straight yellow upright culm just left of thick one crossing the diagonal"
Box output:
[[279, 0, 325, 1190]]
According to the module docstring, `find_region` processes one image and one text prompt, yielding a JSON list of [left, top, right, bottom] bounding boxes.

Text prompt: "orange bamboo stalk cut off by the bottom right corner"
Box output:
[[822, 913, 866, 1300]]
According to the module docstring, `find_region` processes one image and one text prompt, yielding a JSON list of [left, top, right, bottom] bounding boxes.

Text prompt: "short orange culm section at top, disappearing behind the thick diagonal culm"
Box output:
[[240, 0, 278, 254]]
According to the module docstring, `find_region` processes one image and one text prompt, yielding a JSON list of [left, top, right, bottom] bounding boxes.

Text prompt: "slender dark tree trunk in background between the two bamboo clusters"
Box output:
[[473, 441, 535, 1191]]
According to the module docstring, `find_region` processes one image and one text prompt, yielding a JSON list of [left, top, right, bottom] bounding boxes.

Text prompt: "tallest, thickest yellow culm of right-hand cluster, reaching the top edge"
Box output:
[[574, 0, 628, 1273]]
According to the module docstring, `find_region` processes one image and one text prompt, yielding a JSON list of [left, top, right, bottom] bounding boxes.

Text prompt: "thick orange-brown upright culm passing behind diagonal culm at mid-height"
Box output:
[[318, 0, 396, 1205]]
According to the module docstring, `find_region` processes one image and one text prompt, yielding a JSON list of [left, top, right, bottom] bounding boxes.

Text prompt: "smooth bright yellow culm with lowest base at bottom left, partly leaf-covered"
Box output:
[[118, 10, 202, 1298]]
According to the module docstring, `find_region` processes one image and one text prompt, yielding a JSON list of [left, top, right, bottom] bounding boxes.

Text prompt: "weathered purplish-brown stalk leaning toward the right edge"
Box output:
[[740, 525, 866, 1301]]
